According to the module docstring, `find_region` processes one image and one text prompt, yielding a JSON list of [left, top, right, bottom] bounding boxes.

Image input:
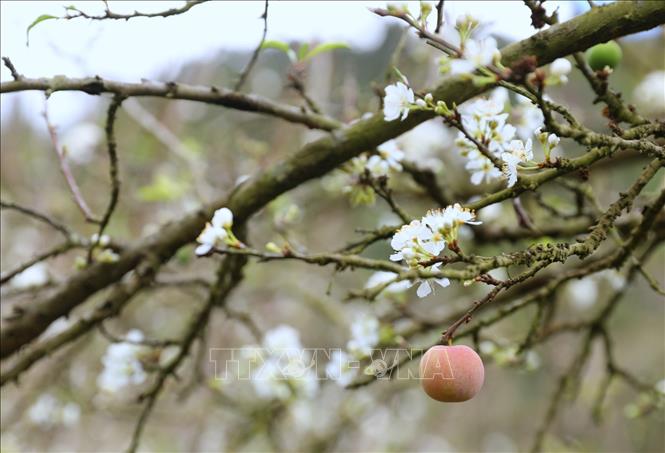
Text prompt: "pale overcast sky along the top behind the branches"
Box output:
[[0, 0, 588, 126]]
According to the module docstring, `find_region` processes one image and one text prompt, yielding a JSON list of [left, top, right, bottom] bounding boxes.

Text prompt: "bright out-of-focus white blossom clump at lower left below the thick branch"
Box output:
[[97, 329, 147, 393]]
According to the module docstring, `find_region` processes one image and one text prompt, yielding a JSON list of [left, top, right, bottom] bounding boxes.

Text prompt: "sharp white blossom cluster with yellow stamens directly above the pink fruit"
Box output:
[[390, 203, 482, 297]]
